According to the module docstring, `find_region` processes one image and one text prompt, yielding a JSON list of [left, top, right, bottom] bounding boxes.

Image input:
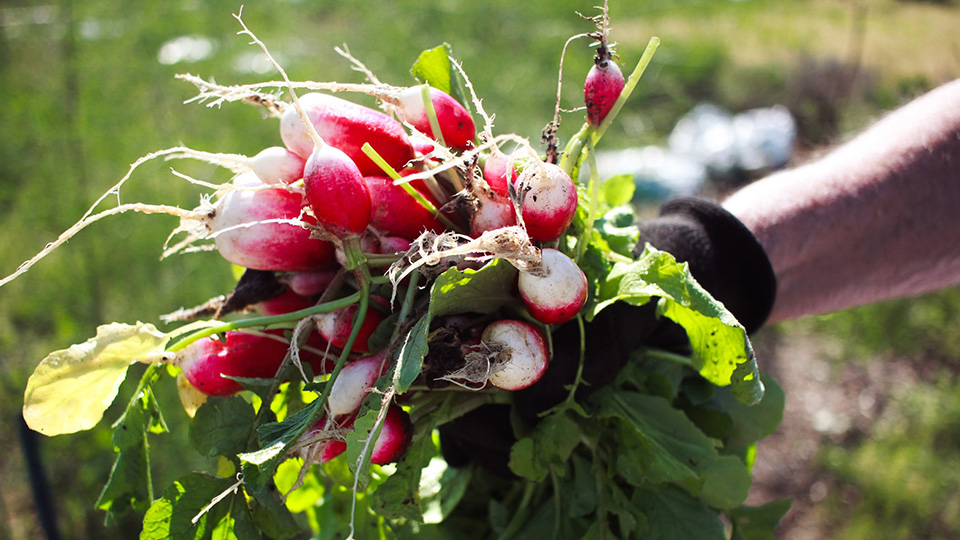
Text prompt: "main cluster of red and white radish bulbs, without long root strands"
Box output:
[[158, 47, 612, 463]]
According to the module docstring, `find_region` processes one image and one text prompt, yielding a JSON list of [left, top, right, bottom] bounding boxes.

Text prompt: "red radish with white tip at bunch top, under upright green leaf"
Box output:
[[397, 86, 477, 150]]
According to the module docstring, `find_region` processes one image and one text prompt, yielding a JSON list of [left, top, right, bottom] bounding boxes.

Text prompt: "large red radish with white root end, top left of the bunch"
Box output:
[[280, 92, 414, 175]]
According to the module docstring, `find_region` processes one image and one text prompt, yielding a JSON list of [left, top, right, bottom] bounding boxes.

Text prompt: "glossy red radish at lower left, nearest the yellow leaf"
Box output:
[[174, 332, 323, 396]]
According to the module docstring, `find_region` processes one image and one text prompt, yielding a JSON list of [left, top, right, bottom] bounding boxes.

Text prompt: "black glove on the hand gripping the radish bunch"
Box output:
[[440, 197, 776, 477]]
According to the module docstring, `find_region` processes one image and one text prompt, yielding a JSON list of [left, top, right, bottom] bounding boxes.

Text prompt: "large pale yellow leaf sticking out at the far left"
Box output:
[[23, 323, 168, 436]]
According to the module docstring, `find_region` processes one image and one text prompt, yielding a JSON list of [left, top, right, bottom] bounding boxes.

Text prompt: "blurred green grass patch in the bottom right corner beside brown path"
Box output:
[[822, 374, 960, 540]]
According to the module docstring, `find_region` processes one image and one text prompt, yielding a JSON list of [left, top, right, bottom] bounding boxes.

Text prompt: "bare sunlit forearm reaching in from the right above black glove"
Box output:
[[723, 80, 960, 322]]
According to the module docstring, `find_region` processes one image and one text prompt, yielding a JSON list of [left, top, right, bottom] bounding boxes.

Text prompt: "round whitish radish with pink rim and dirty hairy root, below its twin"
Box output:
[[480, 319, 550, 390]]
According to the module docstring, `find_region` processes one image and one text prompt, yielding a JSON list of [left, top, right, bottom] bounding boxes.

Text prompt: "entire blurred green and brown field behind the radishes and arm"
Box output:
[[0, 0, 960, 539]]
